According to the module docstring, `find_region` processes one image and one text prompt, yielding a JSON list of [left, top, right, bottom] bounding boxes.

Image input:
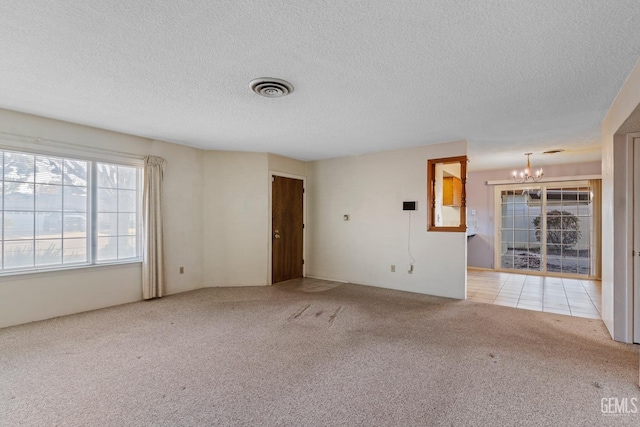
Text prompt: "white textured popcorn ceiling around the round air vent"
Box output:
[[0, 0, 640, 170]]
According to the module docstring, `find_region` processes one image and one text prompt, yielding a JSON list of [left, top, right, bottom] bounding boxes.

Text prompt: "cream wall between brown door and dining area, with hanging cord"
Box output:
[[307, 141, 467, 298]]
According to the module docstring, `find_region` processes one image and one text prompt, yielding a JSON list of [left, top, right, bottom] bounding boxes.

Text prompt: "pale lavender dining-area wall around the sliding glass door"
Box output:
[[467, 162, 601, 268]]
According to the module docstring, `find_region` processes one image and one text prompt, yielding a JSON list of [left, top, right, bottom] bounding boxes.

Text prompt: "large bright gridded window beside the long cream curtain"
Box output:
[[0, 151, 142, 273]]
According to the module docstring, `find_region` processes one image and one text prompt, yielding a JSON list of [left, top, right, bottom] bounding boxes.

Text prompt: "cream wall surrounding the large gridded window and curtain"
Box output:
[[0, 110, 203, 327]]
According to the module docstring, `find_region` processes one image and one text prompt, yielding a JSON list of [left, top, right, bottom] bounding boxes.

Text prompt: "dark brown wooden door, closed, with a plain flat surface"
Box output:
[[271, 175, 304, 283]]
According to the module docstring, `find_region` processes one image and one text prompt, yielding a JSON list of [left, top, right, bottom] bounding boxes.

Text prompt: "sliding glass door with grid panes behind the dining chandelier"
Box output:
[[495, 181, 598, 277]]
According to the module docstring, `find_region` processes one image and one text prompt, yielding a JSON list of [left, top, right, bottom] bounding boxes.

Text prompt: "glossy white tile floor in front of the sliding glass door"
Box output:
[[467, 269, 601, 319]]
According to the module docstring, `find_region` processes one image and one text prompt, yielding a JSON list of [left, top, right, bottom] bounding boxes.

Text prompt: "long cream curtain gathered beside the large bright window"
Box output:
[[142, 156, 166, 299]]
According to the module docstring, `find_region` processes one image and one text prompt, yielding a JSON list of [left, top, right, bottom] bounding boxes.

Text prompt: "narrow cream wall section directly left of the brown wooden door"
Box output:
[[203, 151, 269, 287]]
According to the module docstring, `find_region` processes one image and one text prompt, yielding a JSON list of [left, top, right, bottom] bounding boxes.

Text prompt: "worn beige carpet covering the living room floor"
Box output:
[[0, 283, 640, 426]]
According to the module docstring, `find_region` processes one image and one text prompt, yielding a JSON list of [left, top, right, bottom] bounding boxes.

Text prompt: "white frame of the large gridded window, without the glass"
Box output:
[[0, 143, 144, 278]]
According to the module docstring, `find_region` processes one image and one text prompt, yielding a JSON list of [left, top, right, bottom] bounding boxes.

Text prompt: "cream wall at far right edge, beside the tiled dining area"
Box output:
[[602, 57, 640, 342]]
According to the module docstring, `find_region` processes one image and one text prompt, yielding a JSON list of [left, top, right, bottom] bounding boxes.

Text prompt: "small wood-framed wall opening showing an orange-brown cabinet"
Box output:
[[427, 156, 467, 232]]
